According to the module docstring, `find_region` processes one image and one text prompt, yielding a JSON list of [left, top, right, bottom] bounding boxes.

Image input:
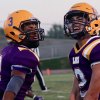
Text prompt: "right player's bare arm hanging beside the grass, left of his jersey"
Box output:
[[70, 78, 80, 100]]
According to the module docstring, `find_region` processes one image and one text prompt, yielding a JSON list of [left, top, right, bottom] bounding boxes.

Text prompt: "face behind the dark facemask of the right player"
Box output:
[[68, 16, 86, 33]]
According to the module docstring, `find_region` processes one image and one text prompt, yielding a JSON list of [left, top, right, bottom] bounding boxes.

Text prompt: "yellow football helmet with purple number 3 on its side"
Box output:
[[4, 10, 44, 47]]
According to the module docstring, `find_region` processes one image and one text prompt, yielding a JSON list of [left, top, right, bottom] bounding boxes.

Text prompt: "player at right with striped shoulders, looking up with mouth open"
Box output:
[[64, 3, 100, 100]]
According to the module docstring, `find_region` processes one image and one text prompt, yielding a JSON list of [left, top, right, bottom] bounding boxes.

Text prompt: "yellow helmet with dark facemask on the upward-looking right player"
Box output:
[[64, 3, 98, 39]]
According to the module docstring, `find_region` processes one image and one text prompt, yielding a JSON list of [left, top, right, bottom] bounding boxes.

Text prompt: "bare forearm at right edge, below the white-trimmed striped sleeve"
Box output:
[[84, 63, 100, 100]]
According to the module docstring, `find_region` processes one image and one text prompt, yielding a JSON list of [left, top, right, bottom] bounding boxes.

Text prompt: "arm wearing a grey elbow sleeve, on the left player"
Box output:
[[3, 70, 26, 100]]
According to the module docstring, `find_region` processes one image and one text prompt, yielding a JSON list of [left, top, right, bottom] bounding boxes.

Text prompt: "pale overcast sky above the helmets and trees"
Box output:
[[0, 0, 100, 30]]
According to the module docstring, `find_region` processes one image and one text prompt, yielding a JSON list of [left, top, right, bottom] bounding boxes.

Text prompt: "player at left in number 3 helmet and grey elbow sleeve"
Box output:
[[0, 10, 44, 100]]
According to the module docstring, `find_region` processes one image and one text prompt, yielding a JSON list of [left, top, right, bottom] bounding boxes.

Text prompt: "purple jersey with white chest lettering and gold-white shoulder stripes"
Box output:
[[69, 36, 100, 97]]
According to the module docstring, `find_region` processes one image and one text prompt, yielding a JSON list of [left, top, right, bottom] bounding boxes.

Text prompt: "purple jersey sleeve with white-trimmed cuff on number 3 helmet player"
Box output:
[[11, 47, 39, 72]]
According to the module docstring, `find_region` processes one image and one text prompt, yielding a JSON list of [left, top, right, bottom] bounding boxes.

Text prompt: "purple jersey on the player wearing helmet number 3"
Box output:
[[0, 43, 39, 100]]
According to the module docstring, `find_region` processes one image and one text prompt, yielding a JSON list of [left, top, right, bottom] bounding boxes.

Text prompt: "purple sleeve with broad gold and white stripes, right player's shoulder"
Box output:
[[83, 39, 100, 65]]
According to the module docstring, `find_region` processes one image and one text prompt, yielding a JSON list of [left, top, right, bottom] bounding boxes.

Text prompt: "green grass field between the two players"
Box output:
[[25, 72, 73, 100]]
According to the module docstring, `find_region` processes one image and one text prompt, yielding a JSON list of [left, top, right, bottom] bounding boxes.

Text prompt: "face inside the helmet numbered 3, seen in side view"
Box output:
[[23, 22, 38, 41]]
